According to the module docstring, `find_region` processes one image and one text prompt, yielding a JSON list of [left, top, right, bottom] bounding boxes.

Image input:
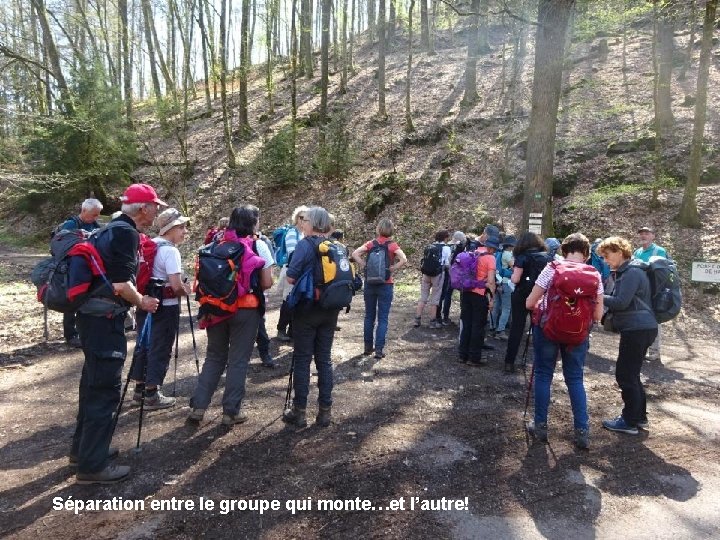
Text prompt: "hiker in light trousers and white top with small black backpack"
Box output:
[[413, 230, 452, 328]]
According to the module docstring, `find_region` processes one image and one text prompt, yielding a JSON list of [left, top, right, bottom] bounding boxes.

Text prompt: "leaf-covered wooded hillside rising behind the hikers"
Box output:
[[122, 21, 720, 330]]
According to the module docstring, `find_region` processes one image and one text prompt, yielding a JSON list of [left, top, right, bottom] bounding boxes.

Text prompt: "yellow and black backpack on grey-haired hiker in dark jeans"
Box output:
[[315, 238, 355, 312]]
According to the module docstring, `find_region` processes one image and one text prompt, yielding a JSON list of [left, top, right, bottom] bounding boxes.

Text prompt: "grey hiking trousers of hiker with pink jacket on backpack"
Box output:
[[190, 309, 261, 415]]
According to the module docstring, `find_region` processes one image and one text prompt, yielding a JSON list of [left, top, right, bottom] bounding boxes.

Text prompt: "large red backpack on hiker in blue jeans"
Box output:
[[540, 261, 600, 345]]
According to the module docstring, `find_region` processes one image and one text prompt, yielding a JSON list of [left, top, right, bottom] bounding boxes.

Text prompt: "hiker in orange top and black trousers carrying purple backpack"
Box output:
[[458, 236, 500, 366]]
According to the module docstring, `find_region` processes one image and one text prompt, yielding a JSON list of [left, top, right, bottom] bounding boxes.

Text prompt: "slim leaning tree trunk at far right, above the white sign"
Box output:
[[678, 0, 718, 229]]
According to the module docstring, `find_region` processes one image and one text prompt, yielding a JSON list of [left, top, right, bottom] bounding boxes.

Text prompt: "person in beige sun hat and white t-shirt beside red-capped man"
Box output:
[[130, 208, 190, 411]]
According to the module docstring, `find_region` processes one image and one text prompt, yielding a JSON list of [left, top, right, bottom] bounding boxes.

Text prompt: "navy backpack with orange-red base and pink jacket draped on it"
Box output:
[[193, 238, 265, 316]]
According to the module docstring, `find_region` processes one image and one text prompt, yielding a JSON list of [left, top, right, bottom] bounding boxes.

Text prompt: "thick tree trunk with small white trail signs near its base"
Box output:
[[520, 0, 575, 236]]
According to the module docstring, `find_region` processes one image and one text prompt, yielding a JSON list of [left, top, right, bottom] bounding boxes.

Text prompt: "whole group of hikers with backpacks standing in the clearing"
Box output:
[[39, 184, 667, 484]]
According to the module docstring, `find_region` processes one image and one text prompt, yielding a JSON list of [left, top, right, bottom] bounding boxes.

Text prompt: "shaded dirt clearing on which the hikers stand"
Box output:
[[0, 254, 720, 538]]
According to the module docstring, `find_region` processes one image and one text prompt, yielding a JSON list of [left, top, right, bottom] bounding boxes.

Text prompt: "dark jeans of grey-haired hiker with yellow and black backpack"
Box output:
[[293, 305, 339, 409]]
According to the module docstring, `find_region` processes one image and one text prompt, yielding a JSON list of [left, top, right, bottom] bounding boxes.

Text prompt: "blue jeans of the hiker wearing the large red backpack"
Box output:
[[533, 326, 590, 429]]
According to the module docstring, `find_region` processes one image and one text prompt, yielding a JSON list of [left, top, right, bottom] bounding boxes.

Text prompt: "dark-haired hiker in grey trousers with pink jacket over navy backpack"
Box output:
[[188, 204, 275, 426]]
